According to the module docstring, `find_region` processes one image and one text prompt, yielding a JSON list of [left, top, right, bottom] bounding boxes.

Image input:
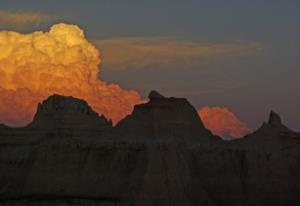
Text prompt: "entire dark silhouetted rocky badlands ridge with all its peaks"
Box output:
[[0, 91, 300, 206]]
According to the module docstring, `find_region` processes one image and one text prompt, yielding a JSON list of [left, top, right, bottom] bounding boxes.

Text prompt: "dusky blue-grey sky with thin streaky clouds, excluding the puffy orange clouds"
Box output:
[[0, 0, 300, 131]]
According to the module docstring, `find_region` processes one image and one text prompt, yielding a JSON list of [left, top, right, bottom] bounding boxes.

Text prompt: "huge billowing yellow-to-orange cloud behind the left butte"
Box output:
[[0, 24, 142, 126]]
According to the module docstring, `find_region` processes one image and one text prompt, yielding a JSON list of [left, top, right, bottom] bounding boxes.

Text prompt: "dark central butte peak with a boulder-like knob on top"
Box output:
[[116, 91, 216, 142]]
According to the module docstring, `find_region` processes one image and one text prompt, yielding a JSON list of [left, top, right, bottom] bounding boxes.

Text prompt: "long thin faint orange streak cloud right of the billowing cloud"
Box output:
[[93, 37, 262, 70]]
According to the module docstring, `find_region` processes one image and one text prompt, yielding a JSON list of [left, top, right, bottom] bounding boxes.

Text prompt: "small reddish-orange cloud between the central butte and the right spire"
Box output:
[[198, 107, 250, 138]]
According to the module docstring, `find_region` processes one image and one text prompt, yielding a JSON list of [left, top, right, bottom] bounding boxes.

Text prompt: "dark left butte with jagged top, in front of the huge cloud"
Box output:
[[29, 94, 112, 129]]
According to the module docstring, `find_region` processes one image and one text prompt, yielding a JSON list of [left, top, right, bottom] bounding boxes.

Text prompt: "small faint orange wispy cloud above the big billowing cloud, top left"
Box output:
[[0, 11, 56, 26]]
